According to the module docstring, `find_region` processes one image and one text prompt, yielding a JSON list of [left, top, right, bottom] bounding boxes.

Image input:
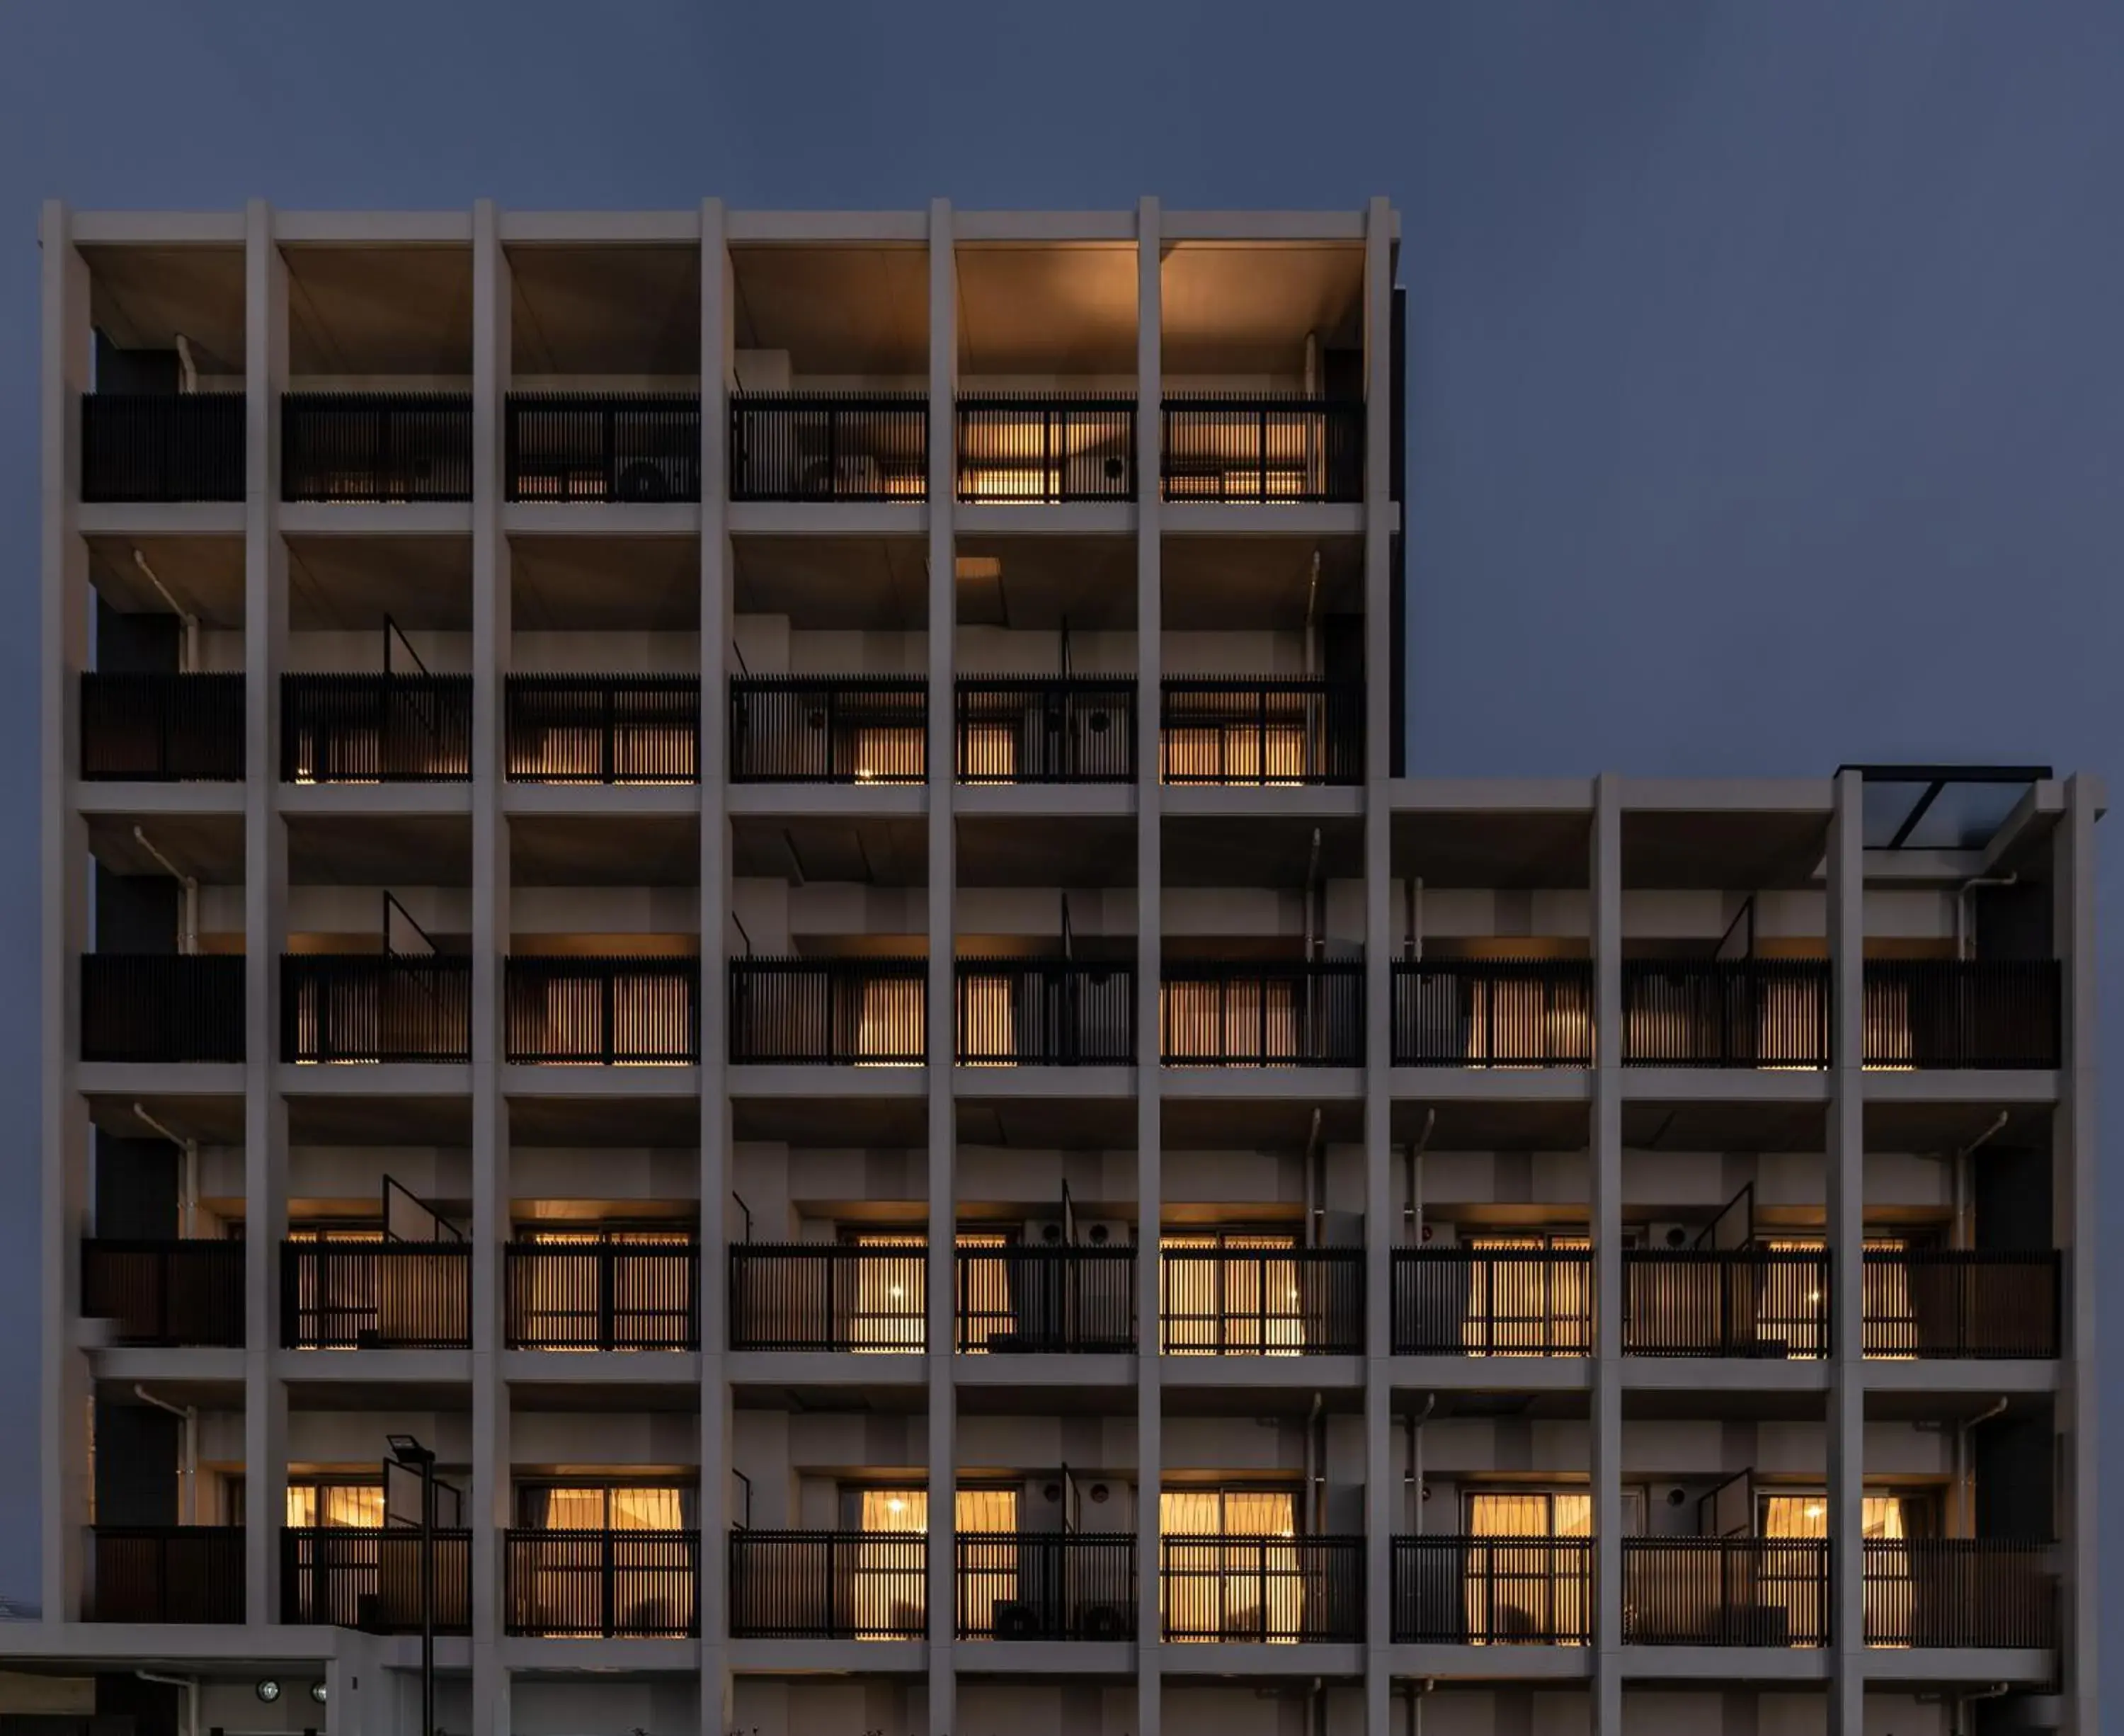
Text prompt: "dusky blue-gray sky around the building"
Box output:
[[0, 0, 2124, 1674]]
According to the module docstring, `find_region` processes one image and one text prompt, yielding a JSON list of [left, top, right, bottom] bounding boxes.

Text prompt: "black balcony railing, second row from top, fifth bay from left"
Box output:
[[954, 675, 1136, 784]]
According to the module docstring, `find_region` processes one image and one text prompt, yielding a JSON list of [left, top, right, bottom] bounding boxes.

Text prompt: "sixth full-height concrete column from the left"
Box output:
[[1136, 198, 1166, 1736]]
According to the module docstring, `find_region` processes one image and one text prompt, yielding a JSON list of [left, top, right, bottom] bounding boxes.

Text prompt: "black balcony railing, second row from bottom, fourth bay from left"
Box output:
[[731, 1241, 928, 1352]]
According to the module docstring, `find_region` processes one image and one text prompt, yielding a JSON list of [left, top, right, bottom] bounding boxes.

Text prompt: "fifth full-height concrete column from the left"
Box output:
[[926, 200, 958, 1736]]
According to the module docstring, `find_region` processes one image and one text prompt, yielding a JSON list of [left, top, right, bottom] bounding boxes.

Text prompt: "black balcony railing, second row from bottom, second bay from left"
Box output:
[[280, 1241, 472, 1349]]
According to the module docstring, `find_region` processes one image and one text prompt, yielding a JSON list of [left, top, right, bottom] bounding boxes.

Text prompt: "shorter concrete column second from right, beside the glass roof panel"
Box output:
[[1822, 771, 1865, 1736]]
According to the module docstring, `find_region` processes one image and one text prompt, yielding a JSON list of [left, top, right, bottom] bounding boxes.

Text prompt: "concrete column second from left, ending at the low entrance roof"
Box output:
[[244, 200, 287, 1621]]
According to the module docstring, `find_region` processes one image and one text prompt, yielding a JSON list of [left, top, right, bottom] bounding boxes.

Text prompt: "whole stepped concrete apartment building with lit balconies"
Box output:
[[16, 200, 2103, 1736]]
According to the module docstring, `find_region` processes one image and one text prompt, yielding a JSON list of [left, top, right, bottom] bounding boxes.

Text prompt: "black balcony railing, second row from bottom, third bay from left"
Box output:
[[501, 1241, 701, 1349]]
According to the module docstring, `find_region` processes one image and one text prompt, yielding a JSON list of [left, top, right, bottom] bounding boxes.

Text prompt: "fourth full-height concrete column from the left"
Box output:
[[697, 189, 737, 1736]]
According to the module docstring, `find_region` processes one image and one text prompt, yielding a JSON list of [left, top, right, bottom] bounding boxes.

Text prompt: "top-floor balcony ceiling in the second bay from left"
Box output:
[[280, 246, 472, 380]]
